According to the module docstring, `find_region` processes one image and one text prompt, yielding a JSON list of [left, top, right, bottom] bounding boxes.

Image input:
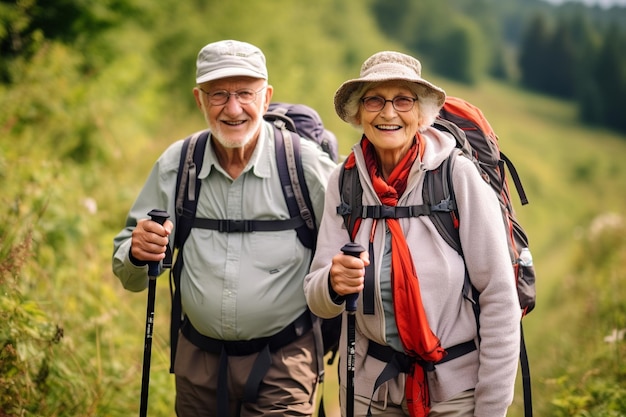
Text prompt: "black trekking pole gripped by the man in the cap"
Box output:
[[139, 210, 170, 417]]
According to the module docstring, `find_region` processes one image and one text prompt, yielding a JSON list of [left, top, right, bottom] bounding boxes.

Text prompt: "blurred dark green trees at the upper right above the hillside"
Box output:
[[372, 0, 626, 132]]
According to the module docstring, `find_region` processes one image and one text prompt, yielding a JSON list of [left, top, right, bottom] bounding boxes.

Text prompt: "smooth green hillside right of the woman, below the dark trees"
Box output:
[[438, 79, 626, 417]]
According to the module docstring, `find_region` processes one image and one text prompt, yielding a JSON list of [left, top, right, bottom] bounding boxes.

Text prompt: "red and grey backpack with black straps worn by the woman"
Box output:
[[337, 97, 535, 417]]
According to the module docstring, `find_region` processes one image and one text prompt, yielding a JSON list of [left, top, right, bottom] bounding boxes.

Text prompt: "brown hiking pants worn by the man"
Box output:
[[174, 331, 318, 417]]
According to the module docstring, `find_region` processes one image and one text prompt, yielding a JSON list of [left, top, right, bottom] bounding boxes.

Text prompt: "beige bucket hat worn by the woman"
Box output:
[[335, 51, 446, 123]]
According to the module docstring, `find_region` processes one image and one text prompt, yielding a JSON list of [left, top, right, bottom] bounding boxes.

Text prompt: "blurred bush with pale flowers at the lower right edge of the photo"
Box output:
[[548, 213, 626, 417]]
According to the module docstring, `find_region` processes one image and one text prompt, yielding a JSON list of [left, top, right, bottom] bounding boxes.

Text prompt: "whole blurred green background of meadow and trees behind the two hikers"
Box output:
[[0, 0, 626, 417]]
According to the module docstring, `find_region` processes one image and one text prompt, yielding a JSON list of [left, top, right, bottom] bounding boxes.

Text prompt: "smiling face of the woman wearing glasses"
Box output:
[[359, 81, 419, 154]]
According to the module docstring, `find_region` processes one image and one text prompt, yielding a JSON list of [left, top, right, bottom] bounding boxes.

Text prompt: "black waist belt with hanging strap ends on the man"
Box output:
[[181, 309, 313, 417]]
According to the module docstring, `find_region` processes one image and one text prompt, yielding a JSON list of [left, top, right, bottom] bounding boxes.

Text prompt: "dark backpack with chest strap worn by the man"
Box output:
[[170, 103, 341, 404]]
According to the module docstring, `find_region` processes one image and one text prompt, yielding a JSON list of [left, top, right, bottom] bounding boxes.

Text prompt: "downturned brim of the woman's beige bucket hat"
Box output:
[[334, 74, 446, 123]]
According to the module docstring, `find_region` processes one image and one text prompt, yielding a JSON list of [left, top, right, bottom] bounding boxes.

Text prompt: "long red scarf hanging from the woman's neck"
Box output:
[[346, 133, 446, 417]]
